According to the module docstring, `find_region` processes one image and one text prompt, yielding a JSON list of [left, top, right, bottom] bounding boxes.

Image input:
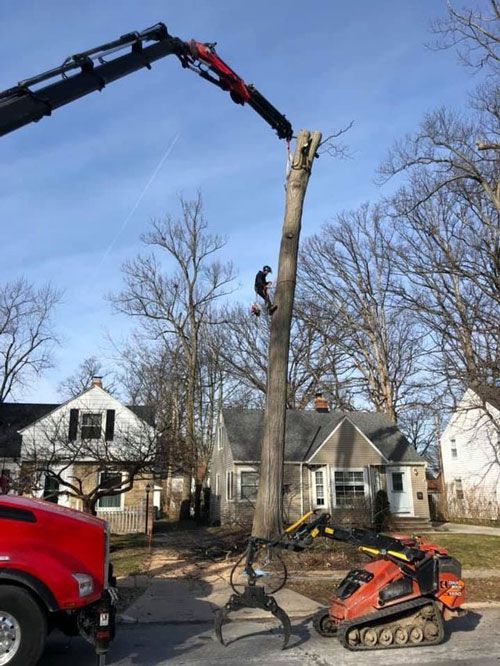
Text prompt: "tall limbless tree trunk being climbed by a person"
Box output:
[[252, 130, 321, 538]]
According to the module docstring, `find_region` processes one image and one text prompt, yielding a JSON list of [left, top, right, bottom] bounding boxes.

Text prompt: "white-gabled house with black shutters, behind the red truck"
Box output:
[[0, 378, 158, 513]]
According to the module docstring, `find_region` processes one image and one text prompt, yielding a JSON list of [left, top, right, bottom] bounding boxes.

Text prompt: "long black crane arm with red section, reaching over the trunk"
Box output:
[[0, 23, 293, 139]]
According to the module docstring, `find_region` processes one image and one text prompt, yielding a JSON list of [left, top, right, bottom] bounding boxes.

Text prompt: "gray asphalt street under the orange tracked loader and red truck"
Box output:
[[40, 608, 500, 666]]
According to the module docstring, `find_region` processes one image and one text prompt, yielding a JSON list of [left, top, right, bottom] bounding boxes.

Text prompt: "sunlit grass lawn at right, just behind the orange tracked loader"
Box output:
[[425, 532, 500, 569]]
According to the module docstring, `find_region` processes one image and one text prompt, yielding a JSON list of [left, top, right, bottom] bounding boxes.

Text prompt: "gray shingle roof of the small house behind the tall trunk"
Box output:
[[222, 408, 425, 463]]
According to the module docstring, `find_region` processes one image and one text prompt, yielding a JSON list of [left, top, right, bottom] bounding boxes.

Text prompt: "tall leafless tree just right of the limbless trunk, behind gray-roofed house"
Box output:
[[301, 205, 424, 420]]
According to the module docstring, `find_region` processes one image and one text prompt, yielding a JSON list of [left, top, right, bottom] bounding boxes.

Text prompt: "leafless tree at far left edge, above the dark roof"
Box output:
[[0, 278, 61, 403]]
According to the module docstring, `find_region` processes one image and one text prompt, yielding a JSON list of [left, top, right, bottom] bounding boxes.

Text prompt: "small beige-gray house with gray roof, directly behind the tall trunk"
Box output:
[[210, 409, 429, 525]]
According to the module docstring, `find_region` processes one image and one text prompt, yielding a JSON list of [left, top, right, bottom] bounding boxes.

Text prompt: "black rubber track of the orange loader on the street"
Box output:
[[337, 597, 444, 652]]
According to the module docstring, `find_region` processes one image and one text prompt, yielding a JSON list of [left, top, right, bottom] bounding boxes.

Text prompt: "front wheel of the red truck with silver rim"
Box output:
[[0, 585, 47, 666]]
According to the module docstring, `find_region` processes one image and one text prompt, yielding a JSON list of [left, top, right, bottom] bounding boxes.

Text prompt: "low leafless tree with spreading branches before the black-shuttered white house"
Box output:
[[19, 415, 158, 515]]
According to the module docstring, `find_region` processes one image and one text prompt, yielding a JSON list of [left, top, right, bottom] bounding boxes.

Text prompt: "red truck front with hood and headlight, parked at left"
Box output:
[[0, 495, 117, 666]]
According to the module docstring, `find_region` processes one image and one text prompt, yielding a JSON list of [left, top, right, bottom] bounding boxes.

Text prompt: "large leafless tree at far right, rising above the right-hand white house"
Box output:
[[386, 182, 500, 390]]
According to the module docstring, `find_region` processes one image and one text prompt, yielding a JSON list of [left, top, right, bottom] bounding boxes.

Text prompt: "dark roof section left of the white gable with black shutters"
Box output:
[[0, 402, 59, 458]]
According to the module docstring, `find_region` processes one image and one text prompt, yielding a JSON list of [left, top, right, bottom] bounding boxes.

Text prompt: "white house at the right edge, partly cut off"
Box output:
[[441, 386, 500, 520]]
